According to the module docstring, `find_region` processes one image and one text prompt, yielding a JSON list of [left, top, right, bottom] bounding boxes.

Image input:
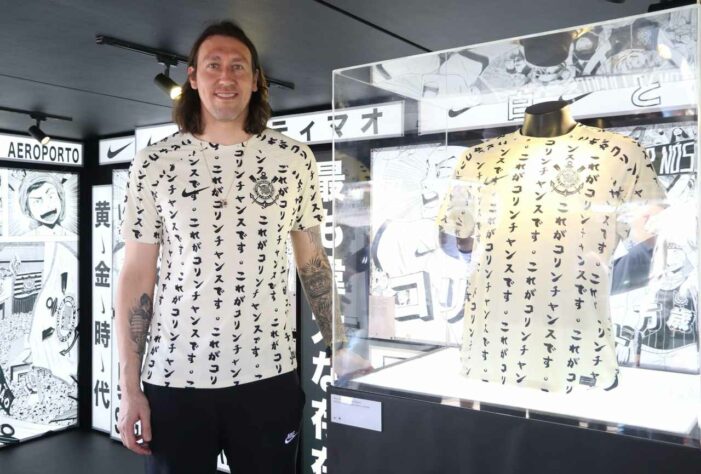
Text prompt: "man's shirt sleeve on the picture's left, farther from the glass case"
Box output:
[[121, 151, 162, 244]]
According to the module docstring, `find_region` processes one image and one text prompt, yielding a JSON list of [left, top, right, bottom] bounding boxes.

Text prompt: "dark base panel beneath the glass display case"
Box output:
[[327, 387, 701, 474]]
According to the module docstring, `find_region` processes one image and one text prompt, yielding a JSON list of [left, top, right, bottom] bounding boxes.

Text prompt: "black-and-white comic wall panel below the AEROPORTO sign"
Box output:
[[0, 169, 79, 446]]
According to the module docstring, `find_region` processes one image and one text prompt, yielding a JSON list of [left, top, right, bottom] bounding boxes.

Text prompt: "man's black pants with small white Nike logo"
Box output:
[[144, 372, 304, 474]]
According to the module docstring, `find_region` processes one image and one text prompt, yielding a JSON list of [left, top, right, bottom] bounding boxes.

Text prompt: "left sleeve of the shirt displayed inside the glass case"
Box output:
[[436, 150, 476, 239]]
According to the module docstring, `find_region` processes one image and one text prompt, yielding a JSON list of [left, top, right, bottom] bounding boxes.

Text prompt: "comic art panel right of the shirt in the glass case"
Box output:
[[611, 122, 699, 373]]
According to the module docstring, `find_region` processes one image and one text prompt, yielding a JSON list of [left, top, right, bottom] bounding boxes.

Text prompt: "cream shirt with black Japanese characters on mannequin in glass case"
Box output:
[[438, 124, 664, 392]]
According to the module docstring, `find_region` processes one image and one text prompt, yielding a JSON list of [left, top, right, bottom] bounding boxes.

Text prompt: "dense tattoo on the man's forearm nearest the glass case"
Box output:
[[299, 228, 345, 346]]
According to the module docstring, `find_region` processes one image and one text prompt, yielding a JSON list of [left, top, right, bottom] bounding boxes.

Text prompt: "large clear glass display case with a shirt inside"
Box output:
[[332, 6, 701, 446]]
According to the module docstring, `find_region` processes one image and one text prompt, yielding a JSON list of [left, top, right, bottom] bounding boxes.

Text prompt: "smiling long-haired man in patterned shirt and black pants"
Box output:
[[116, 22, 362, 473]]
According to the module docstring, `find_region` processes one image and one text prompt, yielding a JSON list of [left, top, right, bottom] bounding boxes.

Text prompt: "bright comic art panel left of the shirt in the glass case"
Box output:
[[369, 145, 469, 343]]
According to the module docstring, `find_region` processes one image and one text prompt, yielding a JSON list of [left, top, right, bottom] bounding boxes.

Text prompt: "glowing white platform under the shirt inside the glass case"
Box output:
[[353, 347, 701, 436]]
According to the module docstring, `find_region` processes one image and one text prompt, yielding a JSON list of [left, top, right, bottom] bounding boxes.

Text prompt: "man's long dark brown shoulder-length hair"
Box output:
[[173, 21, 272, 135]]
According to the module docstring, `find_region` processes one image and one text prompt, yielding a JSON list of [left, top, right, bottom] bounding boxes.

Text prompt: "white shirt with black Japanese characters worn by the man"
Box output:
[[122, 129, 324, 388]]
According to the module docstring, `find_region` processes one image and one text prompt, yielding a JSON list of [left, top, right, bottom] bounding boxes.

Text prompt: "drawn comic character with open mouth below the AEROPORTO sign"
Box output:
[[19, 173, 77, 239]]
